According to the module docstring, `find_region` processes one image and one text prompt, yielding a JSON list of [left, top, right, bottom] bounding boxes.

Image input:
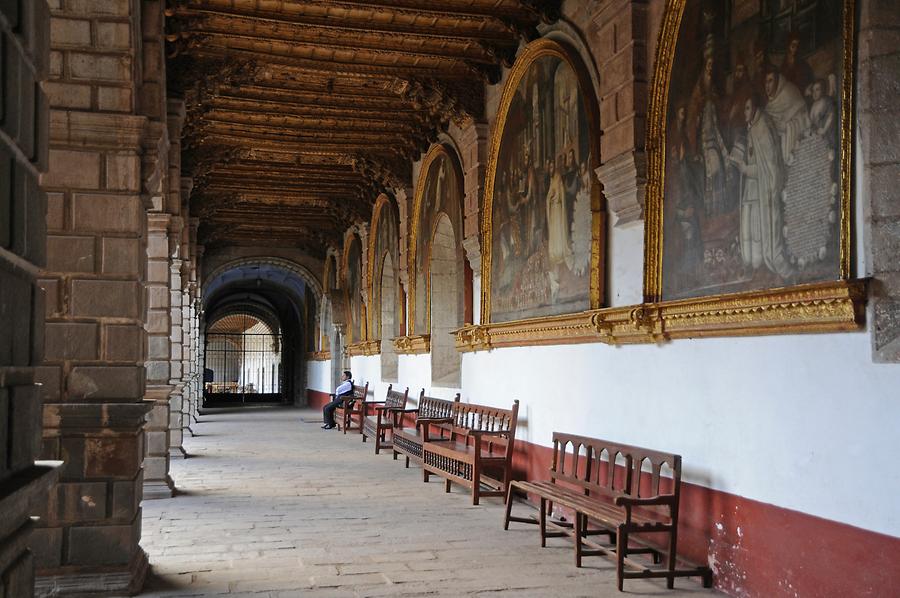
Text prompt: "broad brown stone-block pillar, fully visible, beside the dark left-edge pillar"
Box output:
[[33, 0, 150, 596]]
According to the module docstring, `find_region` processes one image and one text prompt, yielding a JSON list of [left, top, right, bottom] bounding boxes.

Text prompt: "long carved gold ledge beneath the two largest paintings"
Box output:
[[454, 280, 866, 352]]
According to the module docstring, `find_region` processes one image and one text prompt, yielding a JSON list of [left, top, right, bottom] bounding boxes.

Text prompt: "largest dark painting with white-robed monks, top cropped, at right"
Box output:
[[648, 0, 852, 299]]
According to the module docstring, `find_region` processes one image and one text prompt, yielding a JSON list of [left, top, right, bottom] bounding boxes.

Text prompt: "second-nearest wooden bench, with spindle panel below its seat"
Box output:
[[422, 401, 519, 505]]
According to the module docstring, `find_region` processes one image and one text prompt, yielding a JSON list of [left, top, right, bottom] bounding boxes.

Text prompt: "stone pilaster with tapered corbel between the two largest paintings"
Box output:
[[588, 0, 649, 226]]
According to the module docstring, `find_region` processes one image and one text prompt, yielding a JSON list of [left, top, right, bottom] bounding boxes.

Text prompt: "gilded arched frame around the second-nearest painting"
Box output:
[[478, 38, 606, 330]]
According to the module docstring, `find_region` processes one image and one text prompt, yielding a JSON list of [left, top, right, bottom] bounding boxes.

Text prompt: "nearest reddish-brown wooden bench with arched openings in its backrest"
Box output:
[[503, 432, 712, 591]]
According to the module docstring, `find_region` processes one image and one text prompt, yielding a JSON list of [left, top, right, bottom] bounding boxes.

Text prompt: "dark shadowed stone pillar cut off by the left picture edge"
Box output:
[[0, 0, 65, 596]]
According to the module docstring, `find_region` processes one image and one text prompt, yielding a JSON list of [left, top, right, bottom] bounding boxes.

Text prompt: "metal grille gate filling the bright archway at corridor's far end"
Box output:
[[204, 314, 282, 402]]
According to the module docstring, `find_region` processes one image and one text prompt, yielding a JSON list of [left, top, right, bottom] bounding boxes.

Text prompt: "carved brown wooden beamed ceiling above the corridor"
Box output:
[[166, 0, 560, 255]]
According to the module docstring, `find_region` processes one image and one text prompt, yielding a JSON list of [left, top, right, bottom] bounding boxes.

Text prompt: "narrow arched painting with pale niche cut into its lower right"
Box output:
[[410, 145, 462, 334]]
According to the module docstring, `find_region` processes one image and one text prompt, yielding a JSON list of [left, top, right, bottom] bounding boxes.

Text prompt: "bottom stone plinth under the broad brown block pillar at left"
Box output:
[[34, 548, 150, 598]]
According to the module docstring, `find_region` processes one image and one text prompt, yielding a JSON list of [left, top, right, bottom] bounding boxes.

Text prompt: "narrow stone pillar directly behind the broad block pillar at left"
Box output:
[[144, 212, 175, 499]]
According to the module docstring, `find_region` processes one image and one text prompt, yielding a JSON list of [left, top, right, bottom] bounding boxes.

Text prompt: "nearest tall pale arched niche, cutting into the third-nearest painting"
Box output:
[[428, 213, 465, 388]]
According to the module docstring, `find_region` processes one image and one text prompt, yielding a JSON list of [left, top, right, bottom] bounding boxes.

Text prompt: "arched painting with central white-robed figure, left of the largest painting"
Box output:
[[486, 40, 599, 323]]
